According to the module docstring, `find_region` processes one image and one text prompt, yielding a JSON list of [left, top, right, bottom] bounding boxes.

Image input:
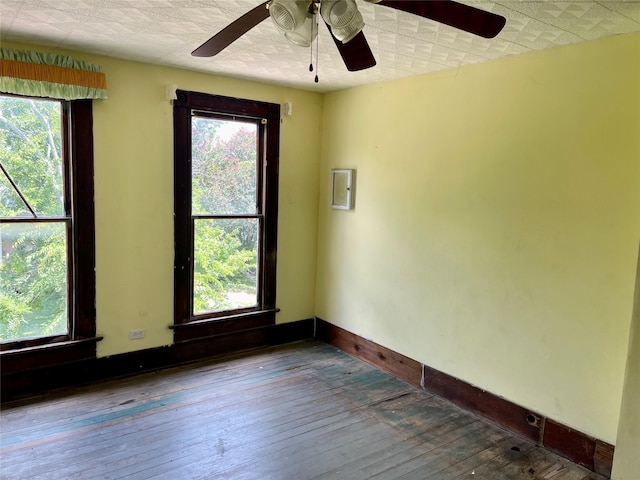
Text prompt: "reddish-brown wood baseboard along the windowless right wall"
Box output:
[[316, 318, 614, 477]]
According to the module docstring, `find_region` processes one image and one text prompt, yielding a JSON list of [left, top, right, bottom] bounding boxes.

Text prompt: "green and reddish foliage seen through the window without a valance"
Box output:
[[192, 117, 258, 313]]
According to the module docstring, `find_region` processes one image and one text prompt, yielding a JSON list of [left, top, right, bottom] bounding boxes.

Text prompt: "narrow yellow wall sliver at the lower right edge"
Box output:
[[611, 242, 640, 480]]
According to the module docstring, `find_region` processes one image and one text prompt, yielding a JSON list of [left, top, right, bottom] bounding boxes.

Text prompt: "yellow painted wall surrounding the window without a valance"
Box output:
[[3, 40, 322, 356]]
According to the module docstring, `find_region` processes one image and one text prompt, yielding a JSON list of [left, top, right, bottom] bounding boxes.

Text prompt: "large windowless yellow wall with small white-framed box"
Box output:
[[316, 35, 640, 443]]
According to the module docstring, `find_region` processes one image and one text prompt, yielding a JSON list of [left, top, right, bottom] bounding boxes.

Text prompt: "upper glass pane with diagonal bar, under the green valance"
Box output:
[[0, 96, 65, 217]]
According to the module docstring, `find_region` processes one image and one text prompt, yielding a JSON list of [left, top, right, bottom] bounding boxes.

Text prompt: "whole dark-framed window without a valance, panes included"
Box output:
[[174, 91, 280, 338]]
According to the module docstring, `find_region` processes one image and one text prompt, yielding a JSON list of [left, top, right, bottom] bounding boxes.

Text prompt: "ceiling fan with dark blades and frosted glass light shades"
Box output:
[[191, 0, 506, 72]]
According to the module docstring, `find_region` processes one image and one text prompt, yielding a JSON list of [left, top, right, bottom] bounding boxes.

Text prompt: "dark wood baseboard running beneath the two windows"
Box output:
[[0, 318, 314, 403]]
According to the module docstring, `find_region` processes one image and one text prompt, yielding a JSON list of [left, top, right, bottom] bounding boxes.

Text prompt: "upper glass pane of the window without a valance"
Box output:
[[191, 117, 258, 215]]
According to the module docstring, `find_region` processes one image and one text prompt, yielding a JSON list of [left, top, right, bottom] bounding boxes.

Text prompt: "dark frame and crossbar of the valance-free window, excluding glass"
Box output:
[[174, 90, 280, 326]]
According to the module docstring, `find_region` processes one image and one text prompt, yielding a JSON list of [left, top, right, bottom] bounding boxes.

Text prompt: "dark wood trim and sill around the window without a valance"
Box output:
[[170, 90, 280, 341]]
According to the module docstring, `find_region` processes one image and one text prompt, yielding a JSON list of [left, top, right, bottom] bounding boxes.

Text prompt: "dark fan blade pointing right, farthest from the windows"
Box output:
[[378, 0, 507, 38]]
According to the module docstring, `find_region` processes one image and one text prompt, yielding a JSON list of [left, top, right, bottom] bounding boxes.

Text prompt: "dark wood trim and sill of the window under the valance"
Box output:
[[0, 100, 101, 360]]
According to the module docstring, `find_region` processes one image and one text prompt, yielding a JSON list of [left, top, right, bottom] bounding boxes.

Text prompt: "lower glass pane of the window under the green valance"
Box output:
[[0, 222, 67, 341]]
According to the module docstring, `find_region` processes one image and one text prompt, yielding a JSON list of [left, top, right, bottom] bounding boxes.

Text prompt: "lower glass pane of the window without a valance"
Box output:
[[193, 218, 258, 315]]
